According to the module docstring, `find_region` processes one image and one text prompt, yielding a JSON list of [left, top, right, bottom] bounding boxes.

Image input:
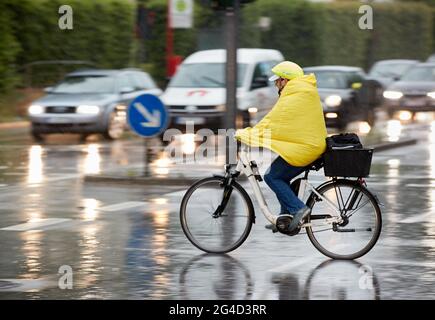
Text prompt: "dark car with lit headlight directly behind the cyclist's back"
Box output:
[[304, 66, 374, 129]]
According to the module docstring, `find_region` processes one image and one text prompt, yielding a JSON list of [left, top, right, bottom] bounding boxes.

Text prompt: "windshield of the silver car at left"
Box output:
[[52, 75, 115, 93]]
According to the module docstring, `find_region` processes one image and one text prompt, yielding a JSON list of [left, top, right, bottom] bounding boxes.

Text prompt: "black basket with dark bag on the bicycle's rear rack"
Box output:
[[324, 133, 373, 178]]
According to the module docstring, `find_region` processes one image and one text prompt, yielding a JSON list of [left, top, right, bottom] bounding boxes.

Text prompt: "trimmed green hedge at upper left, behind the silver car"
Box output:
[[10, 0, 135, 68]]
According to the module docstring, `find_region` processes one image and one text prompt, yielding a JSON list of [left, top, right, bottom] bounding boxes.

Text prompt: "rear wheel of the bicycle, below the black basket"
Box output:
[[306, 180, 382, 260]]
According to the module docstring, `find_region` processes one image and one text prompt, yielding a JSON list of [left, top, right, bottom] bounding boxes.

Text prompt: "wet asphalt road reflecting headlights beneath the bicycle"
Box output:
[[0, 118, 435, 299]]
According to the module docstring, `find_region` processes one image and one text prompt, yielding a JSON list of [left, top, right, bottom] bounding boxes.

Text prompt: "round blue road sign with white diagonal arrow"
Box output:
[[127, 94, 169, 137]]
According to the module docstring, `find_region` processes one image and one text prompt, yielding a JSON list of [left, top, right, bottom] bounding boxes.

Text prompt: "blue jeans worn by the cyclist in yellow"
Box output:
[[264, 157, 305, 214]]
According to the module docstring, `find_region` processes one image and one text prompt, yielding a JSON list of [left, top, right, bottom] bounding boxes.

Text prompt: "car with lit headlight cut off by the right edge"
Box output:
[[384, 63, 435, 116]]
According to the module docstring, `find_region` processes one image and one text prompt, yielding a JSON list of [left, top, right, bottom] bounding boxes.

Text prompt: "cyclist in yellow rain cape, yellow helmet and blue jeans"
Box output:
[[235, 61, 327, 232]]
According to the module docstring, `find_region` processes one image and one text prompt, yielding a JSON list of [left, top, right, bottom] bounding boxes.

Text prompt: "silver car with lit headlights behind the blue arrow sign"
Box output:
[[28, 69, 162, 140]]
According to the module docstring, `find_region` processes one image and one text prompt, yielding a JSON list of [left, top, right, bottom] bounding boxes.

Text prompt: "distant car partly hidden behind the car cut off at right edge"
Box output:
[[368, 59, 418, 89]]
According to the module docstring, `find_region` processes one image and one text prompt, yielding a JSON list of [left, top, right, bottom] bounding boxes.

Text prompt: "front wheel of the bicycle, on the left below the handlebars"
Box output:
[[180, 177, 254, 253]]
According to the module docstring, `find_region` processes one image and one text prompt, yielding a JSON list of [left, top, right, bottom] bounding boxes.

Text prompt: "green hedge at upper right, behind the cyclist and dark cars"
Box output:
[[242, 0, 435, 68]]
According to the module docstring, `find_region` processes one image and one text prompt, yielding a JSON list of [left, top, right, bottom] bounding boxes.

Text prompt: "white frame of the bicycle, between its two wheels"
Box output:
[[235, 146, 342, 227]]
